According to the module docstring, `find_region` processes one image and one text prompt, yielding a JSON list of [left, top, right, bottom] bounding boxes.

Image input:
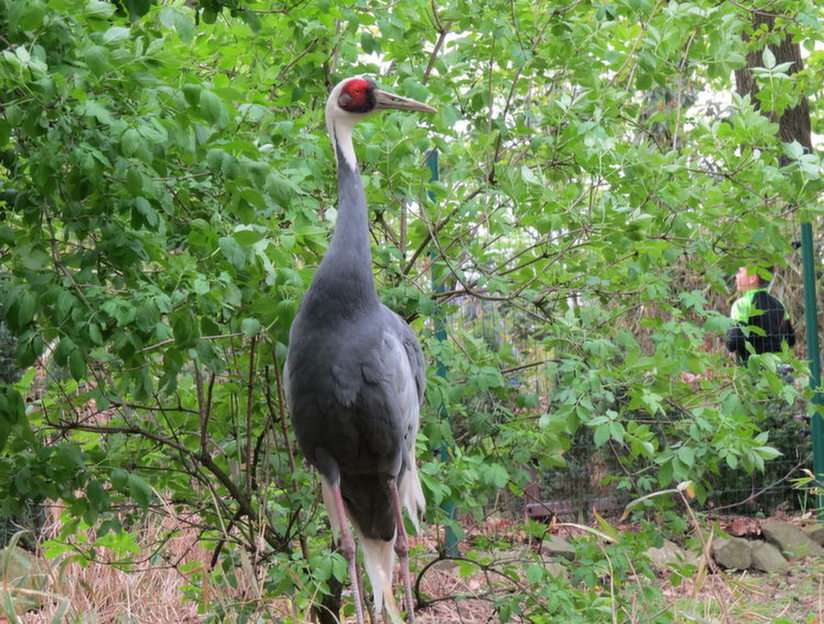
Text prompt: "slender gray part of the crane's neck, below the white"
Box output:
[[304, 140, 379, 318]]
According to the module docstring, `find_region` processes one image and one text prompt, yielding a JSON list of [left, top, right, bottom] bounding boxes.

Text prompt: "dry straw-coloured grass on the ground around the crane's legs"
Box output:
[[14, 507, 508, 624]]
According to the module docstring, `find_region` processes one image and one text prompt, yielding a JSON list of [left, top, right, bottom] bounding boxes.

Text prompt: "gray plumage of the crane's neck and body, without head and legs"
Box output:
[[285, 141, 425, 541]]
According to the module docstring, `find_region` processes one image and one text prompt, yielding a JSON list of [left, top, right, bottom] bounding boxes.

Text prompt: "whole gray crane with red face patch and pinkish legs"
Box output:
[[284, 77, 435, 624]]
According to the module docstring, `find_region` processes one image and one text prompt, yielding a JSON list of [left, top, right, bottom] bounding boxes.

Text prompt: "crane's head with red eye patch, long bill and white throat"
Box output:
[[326, 76, 437, 169]]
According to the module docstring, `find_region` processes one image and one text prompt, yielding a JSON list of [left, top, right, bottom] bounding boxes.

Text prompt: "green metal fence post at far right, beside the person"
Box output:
[[801, 223, 824, 522]]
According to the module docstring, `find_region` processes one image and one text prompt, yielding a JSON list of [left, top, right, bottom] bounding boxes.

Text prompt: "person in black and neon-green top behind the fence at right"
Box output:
[[726, 266, 795, 362]]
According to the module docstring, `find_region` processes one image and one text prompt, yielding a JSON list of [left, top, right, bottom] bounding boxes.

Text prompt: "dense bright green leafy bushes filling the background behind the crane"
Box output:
[[0, 0, 824, 622]]
